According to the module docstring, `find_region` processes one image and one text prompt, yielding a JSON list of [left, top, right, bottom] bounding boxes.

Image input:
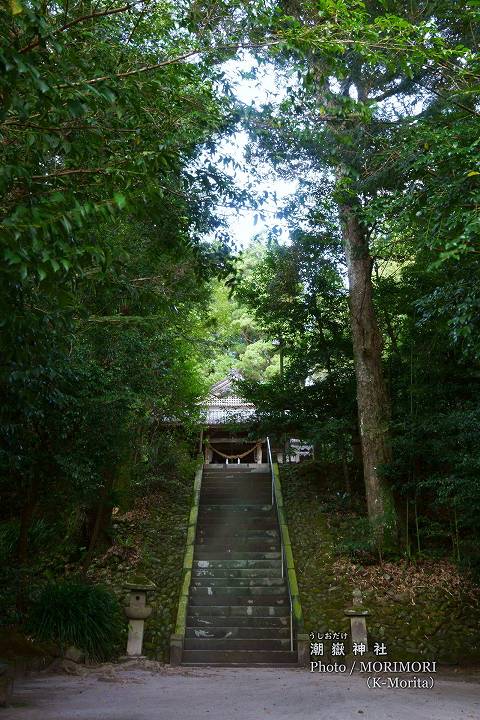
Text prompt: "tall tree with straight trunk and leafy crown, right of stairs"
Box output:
[[240, 2, 475, 542]]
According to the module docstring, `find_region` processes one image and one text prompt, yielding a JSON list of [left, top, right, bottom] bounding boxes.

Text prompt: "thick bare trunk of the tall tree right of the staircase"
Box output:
[[339, 201, 396, 545]]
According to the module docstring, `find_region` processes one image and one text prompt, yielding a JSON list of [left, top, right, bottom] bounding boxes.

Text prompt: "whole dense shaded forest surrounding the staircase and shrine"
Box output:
[[0, 0, 480, 658]]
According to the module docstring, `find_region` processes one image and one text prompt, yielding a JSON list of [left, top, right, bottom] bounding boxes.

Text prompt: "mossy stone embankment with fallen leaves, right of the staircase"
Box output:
[[281, 464, 480, 665]]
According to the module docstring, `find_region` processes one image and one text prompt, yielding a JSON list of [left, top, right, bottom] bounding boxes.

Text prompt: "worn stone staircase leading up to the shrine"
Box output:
[[182, 464, 297, 666]]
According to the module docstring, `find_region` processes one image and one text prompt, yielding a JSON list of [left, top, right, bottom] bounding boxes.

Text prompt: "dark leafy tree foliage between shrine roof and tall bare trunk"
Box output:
[[235, 232, 356, 452]]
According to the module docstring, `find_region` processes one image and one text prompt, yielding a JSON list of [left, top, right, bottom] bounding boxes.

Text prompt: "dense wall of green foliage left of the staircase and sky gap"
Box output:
[[0, 0, 240, 584]]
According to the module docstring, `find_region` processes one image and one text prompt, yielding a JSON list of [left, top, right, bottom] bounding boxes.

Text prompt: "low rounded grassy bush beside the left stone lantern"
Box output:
[[28, 580, 125, 661]]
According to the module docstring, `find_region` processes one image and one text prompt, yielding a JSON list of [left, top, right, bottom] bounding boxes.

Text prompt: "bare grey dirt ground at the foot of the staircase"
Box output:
[[0, 661, 480, 720]]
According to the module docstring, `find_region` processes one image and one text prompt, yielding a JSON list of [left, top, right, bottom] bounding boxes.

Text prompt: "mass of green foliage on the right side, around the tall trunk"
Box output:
[[231, 1, 479, 559]]
